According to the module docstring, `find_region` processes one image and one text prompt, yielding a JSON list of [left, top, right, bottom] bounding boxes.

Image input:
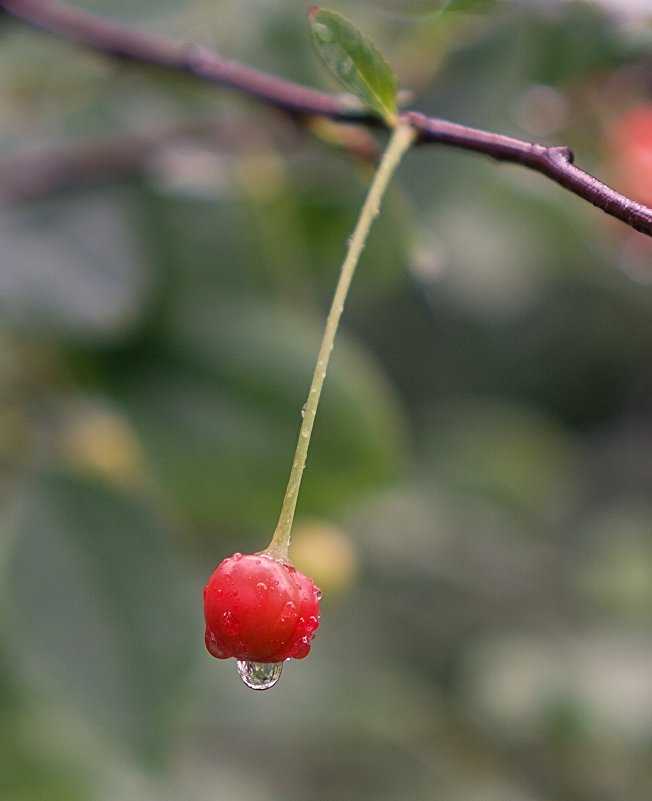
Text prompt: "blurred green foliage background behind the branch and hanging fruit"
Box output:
[[0, 0, 652, 801]]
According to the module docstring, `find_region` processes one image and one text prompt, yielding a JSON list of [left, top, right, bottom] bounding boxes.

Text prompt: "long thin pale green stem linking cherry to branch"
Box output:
[[265, 123, 415, 561]]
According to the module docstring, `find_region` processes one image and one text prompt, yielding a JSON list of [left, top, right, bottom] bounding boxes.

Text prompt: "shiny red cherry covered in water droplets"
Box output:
[[204, 553, 320, 662]]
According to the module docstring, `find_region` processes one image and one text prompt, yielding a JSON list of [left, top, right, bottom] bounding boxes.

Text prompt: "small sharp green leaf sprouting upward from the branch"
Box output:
[[309, 7, 398, 126]]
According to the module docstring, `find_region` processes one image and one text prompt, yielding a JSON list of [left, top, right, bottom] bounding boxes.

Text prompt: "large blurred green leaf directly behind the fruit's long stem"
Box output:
[[111, 297, 405, 532]]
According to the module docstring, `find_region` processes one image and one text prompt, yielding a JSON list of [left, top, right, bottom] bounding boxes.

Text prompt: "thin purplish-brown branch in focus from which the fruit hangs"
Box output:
[[0, 0, 652, 236]]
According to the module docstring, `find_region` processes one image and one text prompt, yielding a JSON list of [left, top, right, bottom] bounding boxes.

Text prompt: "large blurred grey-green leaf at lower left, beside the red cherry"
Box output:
[[2, 473, 196, 765]]
